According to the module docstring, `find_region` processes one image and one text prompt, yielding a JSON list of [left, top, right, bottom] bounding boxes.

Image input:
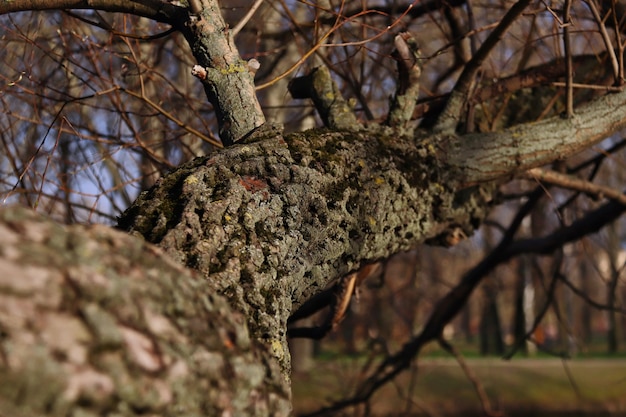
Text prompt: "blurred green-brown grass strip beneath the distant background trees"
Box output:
[[293, 358, 626, 416]]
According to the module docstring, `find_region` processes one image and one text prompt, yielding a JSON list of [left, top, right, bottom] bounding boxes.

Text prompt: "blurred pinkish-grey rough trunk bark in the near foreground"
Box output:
[[0, 208, 290, 417]]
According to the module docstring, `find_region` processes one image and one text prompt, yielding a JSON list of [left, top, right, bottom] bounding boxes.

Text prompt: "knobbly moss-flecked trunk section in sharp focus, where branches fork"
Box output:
[[120, 124, 490, 373]]
